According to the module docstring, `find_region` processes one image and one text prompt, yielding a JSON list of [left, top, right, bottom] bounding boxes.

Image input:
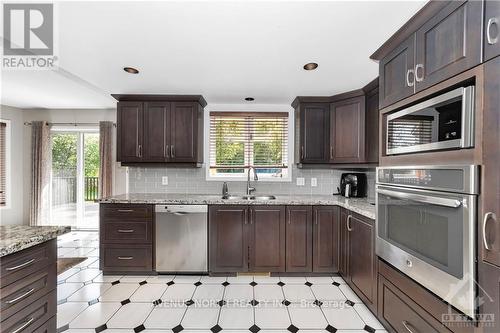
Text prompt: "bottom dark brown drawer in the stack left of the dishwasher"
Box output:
[[101, 245, 153, 272]]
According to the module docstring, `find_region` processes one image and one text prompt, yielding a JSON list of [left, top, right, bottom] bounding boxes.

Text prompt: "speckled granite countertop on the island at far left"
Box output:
[[0, 225, 71, 257]]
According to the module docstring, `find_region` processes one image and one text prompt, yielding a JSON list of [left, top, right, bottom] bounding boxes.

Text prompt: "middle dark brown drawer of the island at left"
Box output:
[[0, 264, 57, 319]]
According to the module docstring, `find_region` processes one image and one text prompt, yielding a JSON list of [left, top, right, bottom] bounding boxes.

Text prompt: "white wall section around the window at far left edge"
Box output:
[[0, 105, 27, 225]]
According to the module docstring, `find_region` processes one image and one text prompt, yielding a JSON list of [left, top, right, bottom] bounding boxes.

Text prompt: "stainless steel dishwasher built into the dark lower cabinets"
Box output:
[[155, 205, 208, 273]]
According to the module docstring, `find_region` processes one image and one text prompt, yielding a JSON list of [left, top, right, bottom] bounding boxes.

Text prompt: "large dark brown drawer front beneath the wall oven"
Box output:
[[377, 260, 472, 333]]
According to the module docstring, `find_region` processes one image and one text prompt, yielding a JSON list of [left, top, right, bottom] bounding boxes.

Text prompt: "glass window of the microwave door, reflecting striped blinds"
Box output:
[[387, 116, 434, 148]]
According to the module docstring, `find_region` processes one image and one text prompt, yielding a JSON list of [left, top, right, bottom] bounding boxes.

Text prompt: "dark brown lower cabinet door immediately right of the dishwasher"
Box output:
[[209, 205, 248, 272]]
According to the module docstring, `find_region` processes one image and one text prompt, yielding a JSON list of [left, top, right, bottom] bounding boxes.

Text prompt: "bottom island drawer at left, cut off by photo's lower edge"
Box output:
[[2, 290, 57, 333]]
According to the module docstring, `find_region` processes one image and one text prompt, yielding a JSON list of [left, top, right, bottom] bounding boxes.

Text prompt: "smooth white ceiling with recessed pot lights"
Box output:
[[1, 1, 425, 108]]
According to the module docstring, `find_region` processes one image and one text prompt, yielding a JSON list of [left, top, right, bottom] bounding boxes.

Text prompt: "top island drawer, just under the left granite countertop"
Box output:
[[0, 239, 57, 288]]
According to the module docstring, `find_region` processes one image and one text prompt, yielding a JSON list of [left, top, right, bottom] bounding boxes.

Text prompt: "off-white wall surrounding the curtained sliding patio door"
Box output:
[[19, 109, 127, 223]]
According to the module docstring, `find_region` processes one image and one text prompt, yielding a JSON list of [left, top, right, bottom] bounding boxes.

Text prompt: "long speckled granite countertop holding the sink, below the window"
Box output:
[[99, 193, 375, 219]]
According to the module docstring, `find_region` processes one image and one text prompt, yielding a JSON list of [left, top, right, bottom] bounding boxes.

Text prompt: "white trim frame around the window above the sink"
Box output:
[[203, 104, 295, 183]]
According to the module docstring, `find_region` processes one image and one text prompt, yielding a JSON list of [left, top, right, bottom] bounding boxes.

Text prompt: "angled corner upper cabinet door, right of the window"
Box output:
[[330, 96, 365, 163]]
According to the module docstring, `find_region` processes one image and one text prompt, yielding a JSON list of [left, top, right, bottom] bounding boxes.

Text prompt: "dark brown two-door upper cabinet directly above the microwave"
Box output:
[[370, 1, 483, 108]]
